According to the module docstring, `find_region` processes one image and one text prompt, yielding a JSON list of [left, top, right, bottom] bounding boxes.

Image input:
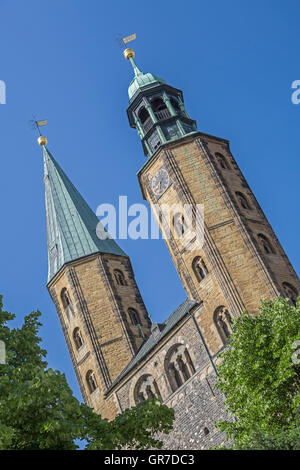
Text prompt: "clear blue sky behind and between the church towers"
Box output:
[[0, 0, 300, 397]]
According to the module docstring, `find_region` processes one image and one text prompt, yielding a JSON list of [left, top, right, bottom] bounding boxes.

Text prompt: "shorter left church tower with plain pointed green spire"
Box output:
[[39, 136, 151, 419]]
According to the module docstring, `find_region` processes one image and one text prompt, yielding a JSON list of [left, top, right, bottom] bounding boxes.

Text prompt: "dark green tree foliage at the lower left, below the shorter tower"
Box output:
[[0, 296, 174, 450]]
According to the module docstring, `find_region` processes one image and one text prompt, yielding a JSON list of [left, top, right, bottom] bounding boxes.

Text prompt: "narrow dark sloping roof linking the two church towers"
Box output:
[[106, 299, 197, 393]]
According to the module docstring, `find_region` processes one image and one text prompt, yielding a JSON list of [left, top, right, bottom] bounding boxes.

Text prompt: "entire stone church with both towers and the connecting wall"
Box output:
[[39, 49, 300, 449]]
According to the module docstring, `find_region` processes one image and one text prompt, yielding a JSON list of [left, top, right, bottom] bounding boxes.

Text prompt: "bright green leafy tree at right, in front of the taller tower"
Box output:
[[217, 297, 300, 449]]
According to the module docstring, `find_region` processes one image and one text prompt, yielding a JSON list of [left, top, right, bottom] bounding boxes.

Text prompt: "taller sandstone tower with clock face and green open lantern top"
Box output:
[[124, 48, 300, 356]]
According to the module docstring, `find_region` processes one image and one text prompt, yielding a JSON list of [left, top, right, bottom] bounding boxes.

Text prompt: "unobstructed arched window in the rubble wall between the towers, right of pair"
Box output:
[[165, 344, 196, 392]]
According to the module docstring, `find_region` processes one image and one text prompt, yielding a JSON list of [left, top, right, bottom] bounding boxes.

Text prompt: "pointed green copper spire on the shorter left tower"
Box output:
[[41, 143, 127, 282]]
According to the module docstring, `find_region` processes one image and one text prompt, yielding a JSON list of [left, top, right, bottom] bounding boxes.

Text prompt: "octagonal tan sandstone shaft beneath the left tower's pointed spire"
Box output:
[[48, 254, 150, 419]]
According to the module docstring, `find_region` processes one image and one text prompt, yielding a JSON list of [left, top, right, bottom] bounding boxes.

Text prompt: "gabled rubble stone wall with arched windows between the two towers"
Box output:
[[114, 308, 231, 449]]
